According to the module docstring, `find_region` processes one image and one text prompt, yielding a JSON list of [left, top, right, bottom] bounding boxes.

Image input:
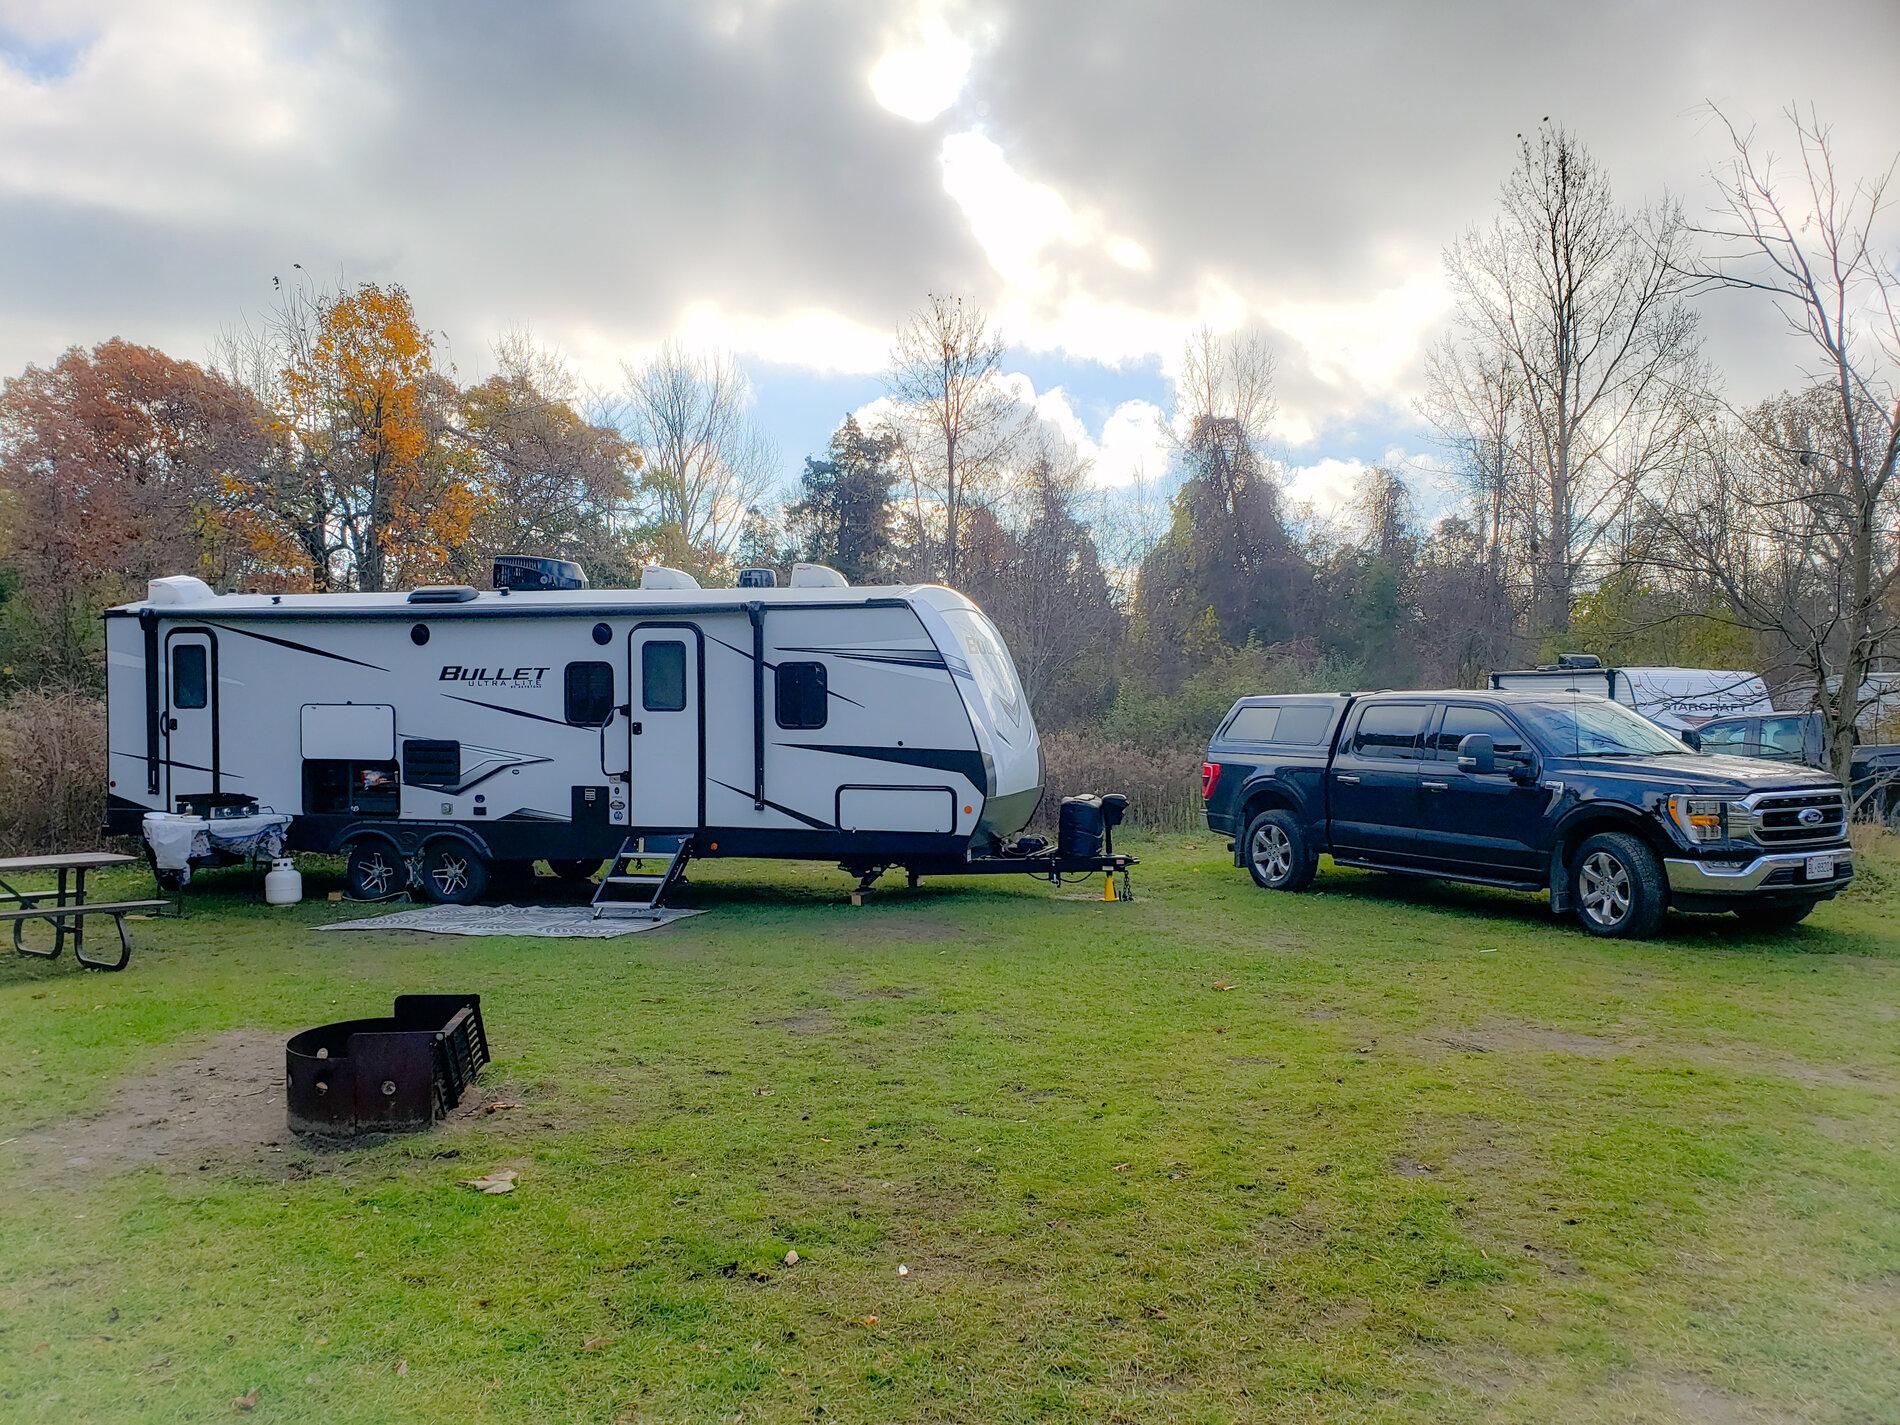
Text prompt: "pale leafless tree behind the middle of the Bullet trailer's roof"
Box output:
[[621, 342, 777, 564]]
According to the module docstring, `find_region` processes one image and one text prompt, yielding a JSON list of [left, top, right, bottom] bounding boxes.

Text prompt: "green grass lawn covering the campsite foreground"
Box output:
[[0, 836, 1900, 1425]]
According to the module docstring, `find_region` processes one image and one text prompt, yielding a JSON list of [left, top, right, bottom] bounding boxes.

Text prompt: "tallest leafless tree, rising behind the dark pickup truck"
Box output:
[[1435, 124, 1699, 629]]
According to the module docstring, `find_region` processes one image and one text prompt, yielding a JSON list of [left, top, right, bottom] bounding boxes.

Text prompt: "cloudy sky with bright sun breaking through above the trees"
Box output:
[[0, 0, 1900, 528]]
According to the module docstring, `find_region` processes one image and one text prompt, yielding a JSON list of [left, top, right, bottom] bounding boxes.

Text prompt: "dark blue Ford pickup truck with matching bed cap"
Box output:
[[1201, 692, 1854, 937]]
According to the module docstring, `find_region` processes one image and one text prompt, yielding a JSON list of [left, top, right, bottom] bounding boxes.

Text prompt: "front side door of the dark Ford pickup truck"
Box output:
[[1419, 703, 1550, 880]]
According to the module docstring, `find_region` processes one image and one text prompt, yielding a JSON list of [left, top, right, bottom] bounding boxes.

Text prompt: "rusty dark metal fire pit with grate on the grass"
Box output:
[[285, 994, 488, 1138]]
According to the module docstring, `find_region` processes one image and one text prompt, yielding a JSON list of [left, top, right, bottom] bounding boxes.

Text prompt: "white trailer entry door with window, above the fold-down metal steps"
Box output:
[[627, 623, 705, 834]]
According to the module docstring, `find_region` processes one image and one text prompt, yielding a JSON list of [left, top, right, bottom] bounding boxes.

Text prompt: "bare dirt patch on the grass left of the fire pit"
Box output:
[[10, 1030, 295, 1182]]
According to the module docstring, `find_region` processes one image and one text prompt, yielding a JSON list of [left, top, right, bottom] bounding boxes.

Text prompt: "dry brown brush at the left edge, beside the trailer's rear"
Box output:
[[0, 688, 106, 855]]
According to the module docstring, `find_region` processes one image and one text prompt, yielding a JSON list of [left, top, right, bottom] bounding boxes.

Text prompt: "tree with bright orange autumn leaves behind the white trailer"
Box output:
[[271, 283, 483, 591]]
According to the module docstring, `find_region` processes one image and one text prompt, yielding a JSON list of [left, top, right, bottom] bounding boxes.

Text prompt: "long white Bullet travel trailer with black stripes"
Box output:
[[106, 557, 1131, 910]]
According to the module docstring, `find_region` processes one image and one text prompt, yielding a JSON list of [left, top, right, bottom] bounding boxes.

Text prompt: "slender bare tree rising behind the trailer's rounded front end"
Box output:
[[885, 293, 1011, 583]]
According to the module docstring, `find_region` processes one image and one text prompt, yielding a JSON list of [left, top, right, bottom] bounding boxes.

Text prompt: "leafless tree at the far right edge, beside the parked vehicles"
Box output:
[[1659, 110, 1900, 779]]
